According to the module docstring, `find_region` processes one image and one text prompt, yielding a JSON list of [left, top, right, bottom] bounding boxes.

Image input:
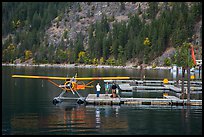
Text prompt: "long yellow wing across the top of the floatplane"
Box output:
[[12, 75, 130, 81]]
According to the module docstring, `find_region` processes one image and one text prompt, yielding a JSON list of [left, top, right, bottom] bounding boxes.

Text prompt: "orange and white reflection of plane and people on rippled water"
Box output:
[[58, 103, 128, 132]]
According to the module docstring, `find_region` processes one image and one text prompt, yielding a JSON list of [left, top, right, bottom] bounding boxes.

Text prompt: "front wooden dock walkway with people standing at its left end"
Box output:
[[85, 94, 202, 105]]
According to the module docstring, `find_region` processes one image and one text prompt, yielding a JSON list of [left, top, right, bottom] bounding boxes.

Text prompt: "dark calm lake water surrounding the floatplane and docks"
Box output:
[[2, 66, 202, 135]]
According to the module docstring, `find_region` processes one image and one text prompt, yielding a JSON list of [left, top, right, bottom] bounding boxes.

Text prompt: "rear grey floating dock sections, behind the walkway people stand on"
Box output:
[[109, 80, 202, 97]]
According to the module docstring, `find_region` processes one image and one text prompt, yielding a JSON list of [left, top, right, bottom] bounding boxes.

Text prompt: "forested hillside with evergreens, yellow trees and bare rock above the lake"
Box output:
[[2, 2, 202, 65]]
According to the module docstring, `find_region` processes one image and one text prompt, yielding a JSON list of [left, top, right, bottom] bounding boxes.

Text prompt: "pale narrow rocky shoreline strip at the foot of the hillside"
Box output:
[[2, 63, 172, 70]]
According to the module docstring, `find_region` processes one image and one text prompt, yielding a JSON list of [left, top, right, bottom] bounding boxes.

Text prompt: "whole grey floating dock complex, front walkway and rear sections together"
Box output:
[[93, 80, 202, 106]]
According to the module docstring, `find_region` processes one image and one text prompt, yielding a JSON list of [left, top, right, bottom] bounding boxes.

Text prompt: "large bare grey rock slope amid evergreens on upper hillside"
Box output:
[[46, 2, 148, 46]]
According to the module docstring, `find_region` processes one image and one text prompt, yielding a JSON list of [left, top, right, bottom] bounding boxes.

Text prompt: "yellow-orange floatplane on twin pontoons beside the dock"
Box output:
[[12, 74, 130, 104]]
